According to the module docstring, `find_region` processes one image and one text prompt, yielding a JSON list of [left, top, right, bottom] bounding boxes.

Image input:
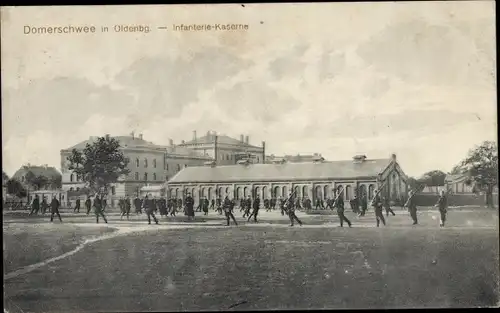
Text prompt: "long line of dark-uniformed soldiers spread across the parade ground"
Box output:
[[29, 185, 448, 227]]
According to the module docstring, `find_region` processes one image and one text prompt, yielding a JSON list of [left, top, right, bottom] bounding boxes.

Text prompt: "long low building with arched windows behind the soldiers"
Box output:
[[165, 154, 408, 203]]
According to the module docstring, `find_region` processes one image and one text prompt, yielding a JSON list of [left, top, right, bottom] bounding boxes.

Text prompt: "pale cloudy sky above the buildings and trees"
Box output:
[[1, 1, 497, 176]]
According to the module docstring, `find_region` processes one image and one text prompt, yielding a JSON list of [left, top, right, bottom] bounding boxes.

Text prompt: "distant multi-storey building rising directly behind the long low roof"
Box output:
[[178, 131, 266, 165]]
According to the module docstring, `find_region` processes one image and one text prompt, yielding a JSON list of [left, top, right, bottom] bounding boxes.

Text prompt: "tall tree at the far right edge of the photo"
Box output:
[[460, 141, 498, 207]]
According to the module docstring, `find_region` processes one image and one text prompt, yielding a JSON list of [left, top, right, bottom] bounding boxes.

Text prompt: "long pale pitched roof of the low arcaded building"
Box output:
[[169, 159, 392, 183]]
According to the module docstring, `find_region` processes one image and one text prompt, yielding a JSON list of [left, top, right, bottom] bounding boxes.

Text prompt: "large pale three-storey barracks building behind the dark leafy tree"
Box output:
[[61, 133, 211, 201]]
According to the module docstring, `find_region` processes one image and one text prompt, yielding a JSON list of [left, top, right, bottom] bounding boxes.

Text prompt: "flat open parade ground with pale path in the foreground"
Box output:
[[3, 207, 499, 312]]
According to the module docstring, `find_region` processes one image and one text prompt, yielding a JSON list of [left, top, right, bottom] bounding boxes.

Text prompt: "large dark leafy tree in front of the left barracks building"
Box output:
[[67, 136, 130, 194]]
